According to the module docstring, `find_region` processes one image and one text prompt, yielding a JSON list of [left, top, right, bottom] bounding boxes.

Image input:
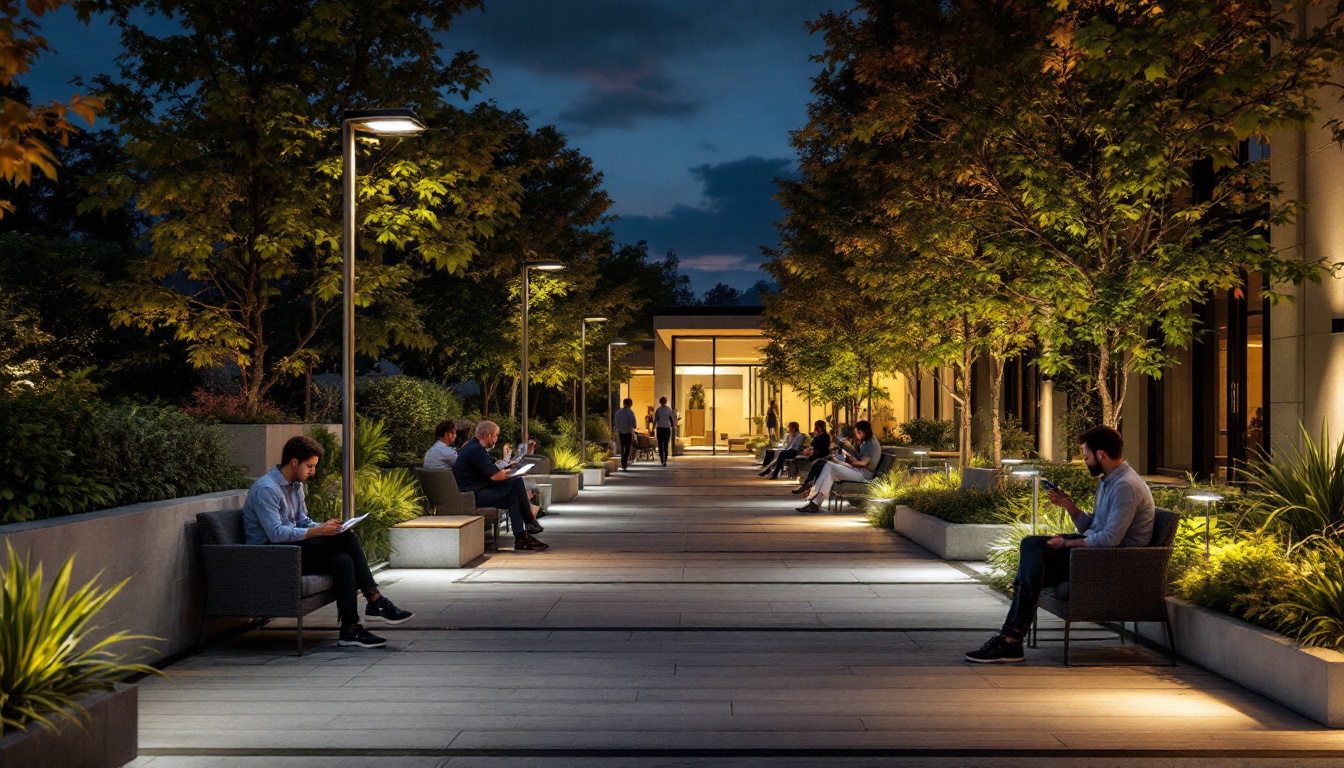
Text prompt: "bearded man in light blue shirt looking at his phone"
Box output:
[[966, 426, 1156, 664]]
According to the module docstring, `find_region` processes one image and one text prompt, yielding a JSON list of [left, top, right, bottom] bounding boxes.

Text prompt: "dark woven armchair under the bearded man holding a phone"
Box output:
[[1031, 507, 1180, 667]]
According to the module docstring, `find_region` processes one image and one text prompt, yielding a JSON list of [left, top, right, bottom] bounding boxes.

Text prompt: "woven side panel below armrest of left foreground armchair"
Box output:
[[200, 545, 302, 616]]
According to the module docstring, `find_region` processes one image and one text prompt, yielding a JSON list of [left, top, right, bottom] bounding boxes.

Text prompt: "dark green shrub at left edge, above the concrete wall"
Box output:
[[0, 375, 116, 523]]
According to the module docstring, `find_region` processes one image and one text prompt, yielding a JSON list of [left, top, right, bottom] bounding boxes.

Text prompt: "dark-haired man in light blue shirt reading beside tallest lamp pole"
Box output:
[[243, 436, 414, 648]]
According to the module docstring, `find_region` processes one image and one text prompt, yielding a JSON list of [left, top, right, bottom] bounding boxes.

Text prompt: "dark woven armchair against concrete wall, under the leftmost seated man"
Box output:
[[196, 510, 336, 656]]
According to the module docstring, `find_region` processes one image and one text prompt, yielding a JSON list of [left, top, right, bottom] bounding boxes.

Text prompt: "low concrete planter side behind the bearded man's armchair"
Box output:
[[1140, 597, 1344, 728]]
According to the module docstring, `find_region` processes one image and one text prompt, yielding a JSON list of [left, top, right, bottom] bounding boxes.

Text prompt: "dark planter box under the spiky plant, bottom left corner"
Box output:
[[0, 685, 140, 768]]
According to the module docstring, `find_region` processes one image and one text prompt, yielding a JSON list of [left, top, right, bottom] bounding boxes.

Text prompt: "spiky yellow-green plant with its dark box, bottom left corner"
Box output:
[[0, 543, 159, 768]]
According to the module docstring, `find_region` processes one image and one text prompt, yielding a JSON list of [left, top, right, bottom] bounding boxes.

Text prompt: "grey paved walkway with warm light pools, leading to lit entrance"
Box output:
[[137, 455, 1344, 768]]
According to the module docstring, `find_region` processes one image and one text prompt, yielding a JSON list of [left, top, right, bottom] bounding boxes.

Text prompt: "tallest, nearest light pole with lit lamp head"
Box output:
[[340, 109, 425, 521]]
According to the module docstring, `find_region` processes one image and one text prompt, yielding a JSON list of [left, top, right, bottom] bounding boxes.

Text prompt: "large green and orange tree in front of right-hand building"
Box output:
[[816, 0, 1340, 425]]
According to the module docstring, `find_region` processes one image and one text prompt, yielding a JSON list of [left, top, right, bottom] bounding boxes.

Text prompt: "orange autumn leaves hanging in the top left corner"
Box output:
[[0, 0, 104, 218]]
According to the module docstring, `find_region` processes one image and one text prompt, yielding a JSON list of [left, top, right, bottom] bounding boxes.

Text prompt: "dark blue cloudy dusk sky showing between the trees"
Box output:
[[27, 0, 845, 293]]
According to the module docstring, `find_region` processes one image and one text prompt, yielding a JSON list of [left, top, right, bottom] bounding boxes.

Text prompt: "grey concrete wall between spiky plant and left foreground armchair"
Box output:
[[0, 491, 247, 662]]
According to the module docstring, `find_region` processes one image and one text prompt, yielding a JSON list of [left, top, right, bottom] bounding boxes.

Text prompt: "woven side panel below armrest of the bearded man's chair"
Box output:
[[1068, 546, 1172, 621]]
